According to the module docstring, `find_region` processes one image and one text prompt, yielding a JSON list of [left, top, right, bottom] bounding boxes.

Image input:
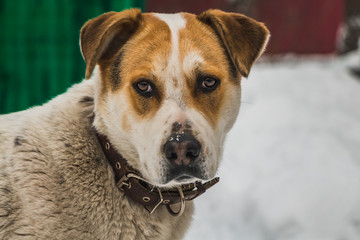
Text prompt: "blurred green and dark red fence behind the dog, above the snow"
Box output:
[[0, 0, 360, 114]]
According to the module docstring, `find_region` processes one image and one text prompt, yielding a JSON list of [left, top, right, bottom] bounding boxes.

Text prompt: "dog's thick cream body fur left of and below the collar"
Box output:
[[0, 90, 190, 239]]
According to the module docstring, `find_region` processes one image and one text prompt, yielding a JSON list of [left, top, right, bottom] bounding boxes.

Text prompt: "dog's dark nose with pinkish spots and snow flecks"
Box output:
[[164, 135, 201, 166]]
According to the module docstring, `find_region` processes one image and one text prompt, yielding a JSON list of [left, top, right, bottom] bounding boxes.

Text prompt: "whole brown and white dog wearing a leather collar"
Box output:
[[0, 9, 269, 240]]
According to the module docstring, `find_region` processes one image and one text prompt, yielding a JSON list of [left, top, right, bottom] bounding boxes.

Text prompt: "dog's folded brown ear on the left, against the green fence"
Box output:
[[80, 9, 142, 79]]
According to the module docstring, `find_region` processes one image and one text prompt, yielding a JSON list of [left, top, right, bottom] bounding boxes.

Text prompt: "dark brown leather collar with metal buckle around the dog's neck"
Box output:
[[97, 133, 219, 216]]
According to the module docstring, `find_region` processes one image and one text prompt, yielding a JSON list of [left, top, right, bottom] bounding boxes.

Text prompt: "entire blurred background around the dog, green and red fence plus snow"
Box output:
[[0, 0, 360, 240]]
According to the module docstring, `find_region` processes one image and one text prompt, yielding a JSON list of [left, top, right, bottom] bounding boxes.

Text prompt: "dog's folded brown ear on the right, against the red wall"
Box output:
[[197, 10, 270, 77]]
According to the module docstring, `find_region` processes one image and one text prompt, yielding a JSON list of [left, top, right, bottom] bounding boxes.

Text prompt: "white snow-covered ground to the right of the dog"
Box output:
[[186, 54, 360, 240]]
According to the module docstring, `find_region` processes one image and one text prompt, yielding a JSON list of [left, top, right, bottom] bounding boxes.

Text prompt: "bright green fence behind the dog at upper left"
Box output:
[[0, 0, 145, 114]]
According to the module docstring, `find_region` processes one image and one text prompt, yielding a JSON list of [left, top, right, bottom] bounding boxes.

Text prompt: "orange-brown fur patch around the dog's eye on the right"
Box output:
[[179, 14, 235, 128]]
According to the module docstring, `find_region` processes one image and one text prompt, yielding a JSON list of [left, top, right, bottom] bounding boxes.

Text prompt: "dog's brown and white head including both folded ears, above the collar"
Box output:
[[80, 10, 268, 187]]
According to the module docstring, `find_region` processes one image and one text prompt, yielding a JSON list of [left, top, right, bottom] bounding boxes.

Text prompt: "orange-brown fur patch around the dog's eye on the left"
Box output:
[[114, 14, 171, 118]]
